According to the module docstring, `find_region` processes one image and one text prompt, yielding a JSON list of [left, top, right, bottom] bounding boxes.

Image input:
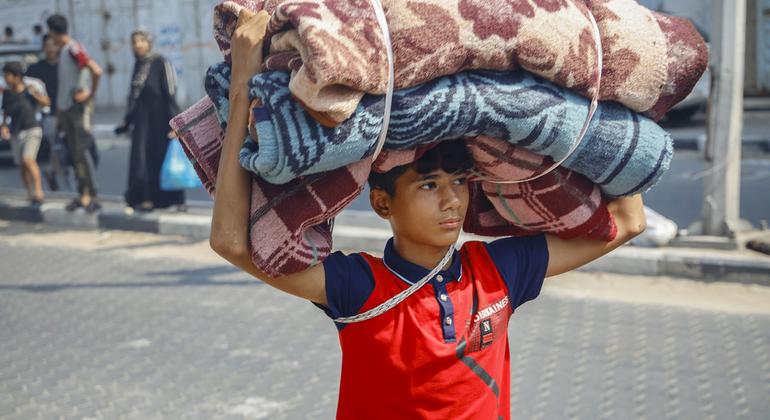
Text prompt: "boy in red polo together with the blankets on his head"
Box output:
[[171, 0, 702, 419]]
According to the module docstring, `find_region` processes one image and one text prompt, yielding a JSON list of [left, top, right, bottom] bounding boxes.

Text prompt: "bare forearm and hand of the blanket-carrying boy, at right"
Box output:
[[545, 194, 647, 277]]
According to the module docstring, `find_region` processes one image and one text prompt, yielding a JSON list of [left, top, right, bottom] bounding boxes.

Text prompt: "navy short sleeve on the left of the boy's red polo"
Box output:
[[316, 251, 374, 319]]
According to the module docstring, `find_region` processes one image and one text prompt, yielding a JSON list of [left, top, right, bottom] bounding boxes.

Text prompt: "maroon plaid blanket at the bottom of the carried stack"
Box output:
[[171, 98, 615, 277]]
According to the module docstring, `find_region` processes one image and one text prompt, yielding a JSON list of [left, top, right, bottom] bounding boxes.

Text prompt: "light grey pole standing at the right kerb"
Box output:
[[703, 0, 746, 236]]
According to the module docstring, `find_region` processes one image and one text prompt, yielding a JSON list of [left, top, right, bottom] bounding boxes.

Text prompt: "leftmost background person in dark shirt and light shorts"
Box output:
[[0, 61, 51, 205]]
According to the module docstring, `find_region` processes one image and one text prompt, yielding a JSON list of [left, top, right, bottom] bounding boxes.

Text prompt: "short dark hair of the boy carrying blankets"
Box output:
[[369, 140, 473, 196]]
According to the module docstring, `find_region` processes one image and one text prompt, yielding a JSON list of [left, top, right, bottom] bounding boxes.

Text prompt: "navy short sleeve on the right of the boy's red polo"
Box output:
[[485, 234, 548, 309]]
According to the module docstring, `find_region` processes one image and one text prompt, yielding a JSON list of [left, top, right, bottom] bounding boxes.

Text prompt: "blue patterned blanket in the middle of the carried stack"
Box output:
[[206, 63, 672, 196]]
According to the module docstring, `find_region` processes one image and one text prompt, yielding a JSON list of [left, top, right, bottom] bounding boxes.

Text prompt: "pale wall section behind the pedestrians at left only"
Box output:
[[0, 0, 222, 107]]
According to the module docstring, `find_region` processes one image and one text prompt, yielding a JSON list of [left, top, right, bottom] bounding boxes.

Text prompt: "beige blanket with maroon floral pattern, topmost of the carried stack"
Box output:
[[214, 0, 708, 123]]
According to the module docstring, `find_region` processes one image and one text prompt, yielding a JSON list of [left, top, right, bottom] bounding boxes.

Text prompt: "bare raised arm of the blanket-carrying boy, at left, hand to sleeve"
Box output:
[[209, 11, 327, 305]]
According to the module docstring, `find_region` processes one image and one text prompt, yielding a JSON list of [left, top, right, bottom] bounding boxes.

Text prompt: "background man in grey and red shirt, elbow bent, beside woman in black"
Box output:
[[46, 14, 102, 213]]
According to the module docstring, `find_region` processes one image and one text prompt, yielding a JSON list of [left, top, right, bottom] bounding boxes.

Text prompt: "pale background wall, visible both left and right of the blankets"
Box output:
[[0, 0, 770, 107]]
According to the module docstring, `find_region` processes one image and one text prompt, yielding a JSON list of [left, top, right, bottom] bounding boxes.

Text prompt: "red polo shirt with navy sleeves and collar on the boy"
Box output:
[[316, 235, 548, 420]]
